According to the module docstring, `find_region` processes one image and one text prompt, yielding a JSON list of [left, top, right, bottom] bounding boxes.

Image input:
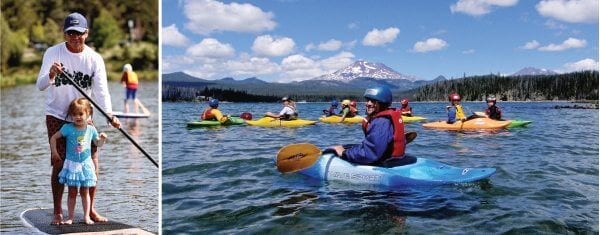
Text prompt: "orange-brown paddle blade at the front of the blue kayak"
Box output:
[[276, 143, 321, 173]]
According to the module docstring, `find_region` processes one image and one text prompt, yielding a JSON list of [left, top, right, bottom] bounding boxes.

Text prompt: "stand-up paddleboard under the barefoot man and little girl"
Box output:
[[21, 208, 153, 234]]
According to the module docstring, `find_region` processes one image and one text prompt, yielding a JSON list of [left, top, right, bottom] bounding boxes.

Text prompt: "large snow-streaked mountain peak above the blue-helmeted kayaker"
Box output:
[[313, 60, 420, 82]]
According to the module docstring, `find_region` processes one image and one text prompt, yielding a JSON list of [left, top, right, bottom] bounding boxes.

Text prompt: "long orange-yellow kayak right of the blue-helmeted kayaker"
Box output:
[[423, 118, 511, 131]]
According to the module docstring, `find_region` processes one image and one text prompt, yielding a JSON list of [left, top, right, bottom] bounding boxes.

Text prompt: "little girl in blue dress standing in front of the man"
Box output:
[[50, 98, 107, 224]]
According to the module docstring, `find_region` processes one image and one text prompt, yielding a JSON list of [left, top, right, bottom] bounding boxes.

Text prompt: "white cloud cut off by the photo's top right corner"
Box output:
[[535, 0, 598, 23]]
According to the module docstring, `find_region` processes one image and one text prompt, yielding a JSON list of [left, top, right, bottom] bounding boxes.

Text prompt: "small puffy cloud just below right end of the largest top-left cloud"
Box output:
[[252, 35, 296, 57]]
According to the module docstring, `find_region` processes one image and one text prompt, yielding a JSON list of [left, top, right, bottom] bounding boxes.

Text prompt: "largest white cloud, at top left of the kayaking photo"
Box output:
[[183, 0, 277, 35]]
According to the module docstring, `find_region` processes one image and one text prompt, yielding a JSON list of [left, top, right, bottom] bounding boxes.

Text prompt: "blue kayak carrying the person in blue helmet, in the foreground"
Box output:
[[298, 153, 496, 187]]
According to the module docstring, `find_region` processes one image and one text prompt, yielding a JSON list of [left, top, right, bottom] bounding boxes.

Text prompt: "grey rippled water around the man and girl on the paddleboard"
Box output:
[[0, 82, 159, 234]]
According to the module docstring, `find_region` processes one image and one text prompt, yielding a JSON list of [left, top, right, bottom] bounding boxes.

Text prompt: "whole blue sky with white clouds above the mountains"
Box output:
[[160, 0, 599, 82]]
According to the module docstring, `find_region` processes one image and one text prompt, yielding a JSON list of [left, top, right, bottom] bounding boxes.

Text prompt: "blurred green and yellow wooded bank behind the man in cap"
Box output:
[[0, 0, 159, 87]]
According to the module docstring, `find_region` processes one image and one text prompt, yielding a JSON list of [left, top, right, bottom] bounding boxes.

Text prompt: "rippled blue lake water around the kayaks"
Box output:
[[162, 102, 599, 234]]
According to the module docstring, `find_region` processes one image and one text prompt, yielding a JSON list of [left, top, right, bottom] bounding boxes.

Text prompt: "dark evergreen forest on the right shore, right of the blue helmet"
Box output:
[[404, 71, 598, 101]]
